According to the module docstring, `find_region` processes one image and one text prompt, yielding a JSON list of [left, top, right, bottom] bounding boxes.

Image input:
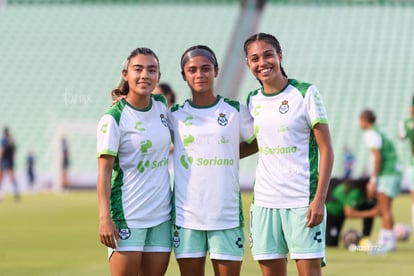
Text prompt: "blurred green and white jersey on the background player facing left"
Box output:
[[364, 125, 400, 176]]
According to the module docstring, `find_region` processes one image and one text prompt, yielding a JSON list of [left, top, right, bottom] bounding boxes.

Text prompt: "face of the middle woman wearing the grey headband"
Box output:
[[183, 56, 218, 94]]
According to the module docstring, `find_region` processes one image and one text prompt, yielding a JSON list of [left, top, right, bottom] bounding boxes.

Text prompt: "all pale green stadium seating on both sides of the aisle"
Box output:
[[0, 0, 414, 190]]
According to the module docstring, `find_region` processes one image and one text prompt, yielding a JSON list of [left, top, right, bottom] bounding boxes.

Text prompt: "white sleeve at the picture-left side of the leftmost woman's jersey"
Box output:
[[97, 114, 120, 158]]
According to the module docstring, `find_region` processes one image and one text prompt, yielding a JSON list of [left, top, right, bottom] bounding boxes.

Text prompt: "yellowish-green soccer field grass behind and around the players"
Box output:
[[0, 191, 414, 276]]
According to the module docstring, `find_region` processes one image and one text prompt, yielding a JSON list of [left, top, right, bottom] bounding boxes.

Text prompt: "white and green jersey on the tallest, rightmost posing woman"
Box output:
[[247, 79, 328, 208]]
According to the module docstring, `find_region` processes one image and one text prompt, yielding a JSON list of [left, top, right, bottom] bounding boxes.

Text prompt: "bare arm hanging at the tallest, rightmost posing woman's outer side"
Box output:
[[306, 124, 334, 227]]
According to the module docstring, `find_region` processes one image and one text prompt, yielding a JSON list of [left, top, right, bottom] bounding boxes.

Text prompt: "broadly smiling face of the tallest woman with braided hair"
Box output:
[[246, 40, 283, 85]]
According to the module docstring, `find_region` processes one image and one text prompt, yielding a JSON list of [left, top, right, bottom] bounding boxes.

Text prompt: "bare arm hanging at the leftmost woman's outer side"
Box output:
[[97, 155, 118, 249]]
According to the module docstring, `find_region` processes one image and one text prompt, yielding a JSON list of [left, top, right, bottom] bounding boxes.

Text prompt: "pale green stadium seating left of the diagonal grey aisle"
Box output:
[[0, 3, 239, 188]]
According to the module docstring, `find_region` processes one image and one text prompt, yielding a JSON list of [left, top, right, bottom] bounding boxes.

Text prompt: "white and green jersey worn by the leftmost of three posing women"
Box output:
[[97, 95, 171, 228]]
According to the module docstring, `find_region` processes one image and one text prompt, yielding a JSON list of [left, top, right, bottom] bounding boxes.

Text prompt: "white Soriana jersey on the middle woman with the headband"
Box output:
[[168, 96, 253, 230]]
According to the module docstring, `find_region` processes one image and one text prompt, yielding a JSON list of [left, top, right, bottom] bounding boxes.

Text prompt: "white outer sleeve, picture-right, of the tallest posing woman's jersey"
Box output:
[[305, 85, 328, 128]]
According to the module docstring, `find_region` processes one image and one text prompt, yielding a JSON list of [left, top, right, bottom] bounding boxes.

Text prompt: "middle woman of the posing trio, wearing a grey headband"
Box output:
[[168, 45, 253, 276]]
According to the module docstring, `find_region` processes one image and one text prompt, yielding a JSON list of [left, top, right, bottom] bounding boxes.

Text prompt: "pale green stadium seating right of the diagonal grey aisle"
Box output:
[[241, 4, 414, 179]]
